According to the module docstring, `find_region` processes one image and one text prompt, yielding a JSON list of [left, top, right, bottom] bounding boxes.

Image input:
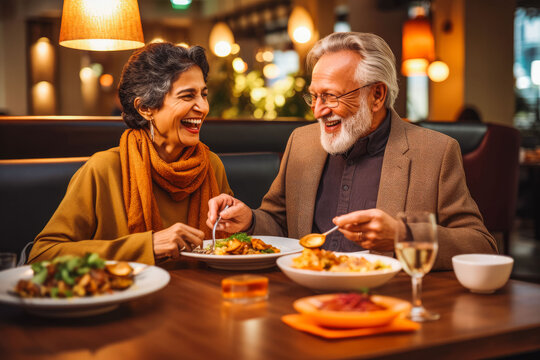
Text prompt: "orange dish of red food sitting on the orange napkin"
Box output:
[[293, 293, 411, 329]]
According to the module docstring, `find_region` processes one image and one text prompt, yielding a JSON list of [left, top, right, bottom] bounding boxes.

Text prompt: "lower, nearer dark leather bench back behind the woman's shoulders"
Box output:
[[0, 152, 280, 253]]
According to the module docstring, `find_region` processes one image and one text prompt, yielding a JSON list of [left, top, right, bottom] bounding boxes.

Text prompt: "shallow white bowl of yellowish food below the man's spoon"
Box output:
[[277, 249, 401, 292]]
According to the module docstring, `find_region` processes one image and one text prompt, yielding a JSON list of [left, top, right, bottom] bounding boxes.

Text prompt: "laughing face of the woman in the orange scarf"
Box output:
[[152, 65, 209, 151]]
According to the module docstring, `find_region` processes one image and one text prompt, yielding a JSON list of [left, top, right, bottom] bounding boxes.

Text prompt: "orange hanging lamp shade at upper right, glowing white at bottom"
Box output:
[[401, 16, 435, 76]]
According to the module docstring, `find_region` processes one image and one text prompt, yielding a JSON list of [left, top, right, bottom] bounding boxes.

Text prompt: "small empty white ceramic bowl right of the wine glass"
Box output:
[[452, 254, 514, 294]]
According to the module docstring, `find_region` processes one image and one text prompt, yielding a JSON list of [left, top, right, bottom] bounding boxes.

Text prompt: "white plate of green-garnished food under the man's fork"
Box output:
[[182, 233, 303, 270]]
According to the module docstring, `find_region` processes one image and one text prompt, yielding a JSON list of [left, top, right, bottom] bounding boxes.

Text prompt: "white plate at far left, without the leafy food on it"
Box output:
[[0, 262, 170, 317]]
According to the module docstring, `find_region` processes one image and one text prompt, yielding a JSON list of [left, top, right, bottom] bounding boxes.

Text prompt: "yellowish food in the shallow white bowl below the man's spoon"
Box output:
[[292, 248, 392, 272]]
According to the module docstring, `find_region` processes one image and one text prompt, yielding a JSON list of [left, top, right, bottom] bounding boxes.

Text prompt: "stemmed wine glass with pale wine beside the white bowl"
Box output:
[[395, 212, 440, 322]]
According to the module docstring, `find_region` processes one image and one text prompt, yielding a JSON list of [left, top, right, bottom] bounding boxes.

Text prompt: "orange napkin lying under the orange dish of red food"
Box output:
[[281, 314, 420, 339]]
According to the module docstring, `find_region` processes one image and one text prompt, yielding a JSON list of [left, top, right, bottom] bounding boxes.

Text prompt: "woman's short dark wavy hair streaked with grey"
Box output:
[[118, 43, 208, 129]]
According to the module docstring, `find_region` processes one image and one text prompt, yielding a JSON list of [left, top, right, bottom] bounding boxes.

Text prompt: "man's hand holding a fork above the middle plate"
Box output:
[[206, 194, 253, 234]]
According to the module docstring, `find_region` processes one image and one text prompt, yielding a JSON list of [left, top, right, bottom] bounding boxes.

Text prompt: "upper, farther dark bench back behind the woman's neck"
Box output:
[[0, 116, 309, 159]]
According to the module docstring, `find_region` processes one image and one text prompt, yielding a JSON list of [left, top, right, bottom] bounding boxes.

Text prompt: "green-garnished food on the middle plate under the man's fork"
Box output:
[[214, 233, 281, 255]]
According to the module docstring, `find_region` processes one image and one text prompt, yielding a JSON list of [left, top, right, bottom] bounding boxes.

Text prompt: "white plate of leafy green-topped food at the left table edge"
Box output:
[[0, 253, 170, 317]]
